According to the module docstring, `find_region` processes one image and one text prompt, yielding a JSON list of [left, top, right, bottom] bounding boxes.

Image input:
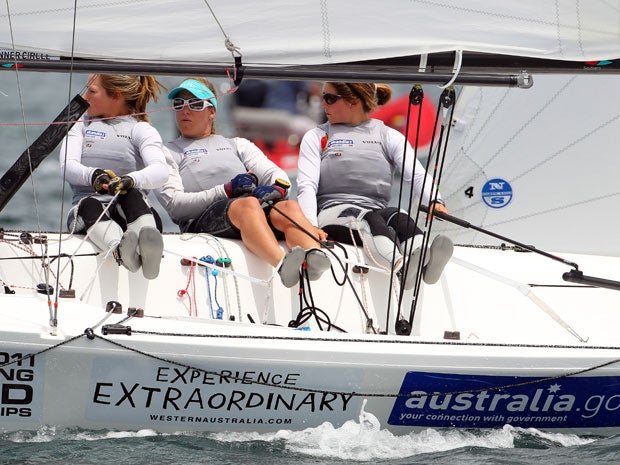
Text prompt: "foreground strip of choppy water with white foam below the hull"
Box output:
[[0, 421, 620, 465]]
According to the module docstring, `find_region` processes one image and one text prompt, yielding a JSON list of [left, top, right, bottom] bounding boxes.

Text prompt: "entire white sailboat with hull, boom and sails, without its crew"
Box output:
[[0, 0, 620, 435]]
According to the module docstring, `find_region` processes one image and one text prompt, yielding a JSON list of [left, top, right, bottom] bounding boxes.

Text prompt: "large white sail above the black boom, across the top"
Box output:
[[0, 0, 620, 65]]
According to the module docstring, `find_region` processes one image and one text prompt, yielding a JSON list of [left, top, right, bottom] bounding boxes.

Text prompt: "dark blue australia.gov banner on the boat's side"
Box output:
[[388, 372, 620, 428]]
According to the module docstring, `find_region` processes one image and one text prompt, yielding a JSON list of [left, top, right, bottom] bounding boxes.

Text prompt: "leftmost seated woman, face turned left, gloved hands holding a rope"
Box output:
[[60, 74, 168, 279]]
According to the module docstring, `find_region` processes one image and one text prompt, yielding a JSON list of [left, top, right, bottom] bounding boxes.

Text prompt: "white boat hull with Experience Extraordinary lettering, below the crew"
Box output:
[[0, 235, 620, 434]]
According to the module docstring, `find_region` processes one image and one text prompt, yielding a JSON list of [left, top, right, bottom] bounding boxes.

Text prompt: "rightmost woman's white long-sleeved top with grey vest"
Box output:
[[297, 119, 440, 225]]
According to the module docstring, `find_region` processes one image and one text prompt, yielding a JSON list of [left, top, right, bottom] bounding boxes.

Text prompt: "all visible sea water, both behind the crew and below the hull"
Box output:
[[0, 71, 620, 465]]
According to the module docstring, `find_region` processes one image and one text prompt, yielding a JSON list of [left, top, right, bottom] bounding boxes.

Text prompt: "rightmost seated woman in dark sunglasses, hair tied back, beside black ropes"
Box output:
[[297, 82, 453, 289]]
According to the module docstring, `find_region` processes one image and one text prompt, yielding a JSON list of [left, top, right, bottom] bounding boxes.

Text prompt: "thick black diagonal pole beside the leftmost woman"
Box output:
[[0, 94, 88, 211]]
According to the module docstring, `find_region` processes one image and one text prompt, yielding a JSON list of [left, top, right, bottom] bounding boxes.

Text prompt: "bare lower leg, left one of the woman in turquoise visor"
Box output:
[[228, 197, 284, 267]]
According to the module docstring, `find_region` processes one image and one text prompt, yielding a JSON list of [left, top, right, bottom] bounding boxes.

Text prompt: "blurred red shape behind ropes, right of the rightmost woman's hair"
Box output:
[[370, 94, 437, 147]]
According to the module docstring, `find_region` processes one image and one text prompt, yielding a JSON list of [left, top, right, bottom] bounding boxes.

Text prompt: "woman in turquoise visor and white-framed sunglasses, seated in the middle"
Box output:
[[156, 78, 331, 287]]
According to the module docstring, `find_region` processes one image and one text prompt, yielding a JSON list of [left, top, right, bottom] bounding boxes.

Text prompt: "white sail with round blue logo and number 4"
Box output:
[[434, 75, 620, 256]]
